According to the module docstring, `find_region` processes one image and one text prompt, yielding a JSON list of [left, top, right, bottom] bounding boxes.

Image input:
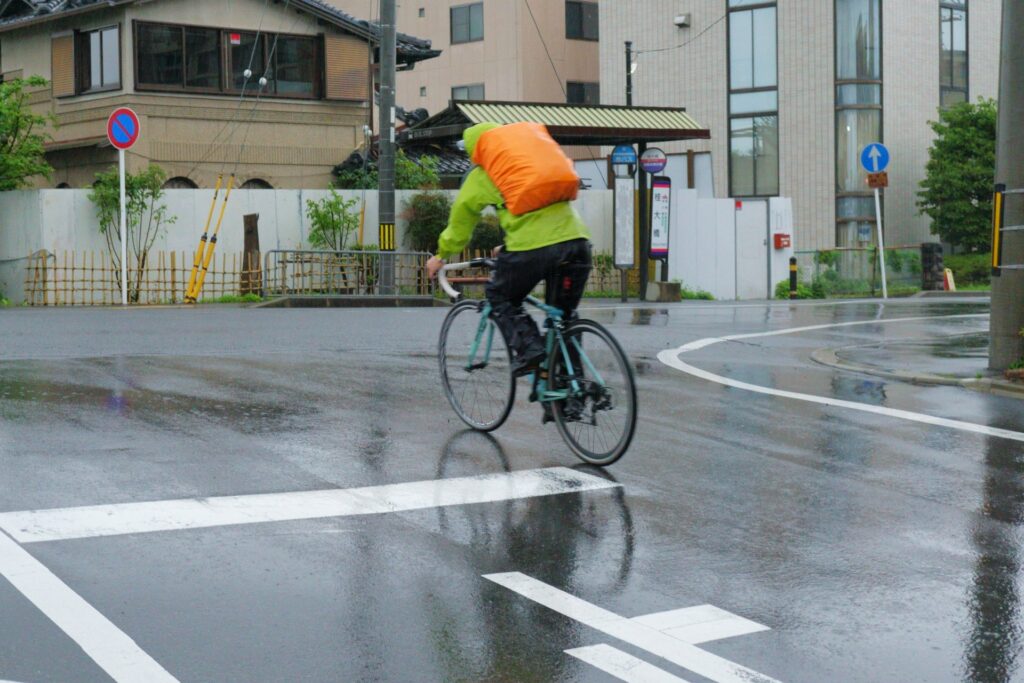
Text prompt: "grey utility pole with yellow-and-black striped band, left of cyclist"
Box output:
[[377, 0, 397, 294]]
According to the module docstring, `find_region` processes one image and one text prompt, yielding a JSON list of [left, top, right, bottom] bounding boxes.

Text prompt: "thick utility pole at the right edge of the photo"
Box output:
[[988, 0, 1024, 371]]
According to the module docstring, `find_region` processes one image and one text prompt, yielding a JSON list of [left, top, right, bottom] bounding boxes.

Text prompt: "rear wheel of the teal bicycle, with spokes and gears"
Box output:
[[548, 319, 637, 467]]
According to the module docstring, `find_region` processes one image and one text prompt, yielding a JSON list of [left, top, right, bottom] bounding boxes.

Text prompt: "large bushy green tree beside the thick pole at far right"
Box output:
[[918, 99, 996, 251]]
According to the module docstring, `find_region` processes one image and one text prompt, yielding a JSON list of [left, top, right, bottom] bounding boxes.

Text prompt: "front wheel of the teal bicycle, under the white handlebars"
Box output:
[[437, 301, 515, 431]]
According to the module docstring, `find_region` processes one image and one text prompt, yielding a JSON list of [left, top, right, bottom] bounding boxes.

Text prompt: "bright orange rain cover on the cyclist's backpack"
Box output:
[[473, 123, 580, 216]]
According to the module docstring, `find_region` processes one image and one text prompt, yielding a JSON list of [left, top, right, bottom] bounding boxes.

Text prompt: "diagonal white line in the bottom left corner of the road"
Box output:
[[0, 533, 177, 683]]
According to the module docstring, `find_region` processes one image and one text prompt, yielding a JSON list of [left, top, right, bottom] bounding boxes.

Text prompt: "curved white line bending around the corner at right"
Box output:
[[657, 313, 1024, 442]]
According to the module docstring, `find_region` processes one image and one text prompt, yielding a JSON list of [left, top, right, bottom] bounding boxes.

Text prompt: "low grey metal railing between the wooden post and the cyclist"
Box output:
[[263, 249, 434, 297]]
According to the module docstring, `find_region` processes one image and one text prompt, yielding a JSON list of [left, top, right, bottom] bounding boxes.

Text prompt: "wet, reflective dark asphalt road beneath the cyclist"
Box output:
[[0, 300, 1024, 683]]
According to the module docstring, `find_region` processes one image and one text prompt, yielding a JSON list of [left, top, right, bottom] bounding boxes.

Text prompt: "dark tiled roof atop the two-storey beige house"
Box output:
[[0, 0, 440, 65]]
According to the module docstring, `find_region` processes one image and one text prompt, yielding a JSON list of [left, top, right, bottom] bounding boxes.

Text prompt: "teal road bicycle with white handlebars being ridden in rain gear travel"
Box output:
[[437, 258, 637, 467]]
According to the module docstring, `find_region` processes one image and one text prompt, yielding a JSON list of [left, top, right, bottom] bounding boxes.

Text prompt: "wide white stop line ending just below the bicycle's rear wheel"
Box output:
[[0, 467, 621, 543]]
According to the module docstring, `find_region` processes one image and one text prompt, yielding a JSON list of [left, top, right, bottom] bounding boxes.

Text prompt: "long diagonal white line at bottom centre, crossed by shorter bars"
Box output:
[[483, 571, 777, 683]]
